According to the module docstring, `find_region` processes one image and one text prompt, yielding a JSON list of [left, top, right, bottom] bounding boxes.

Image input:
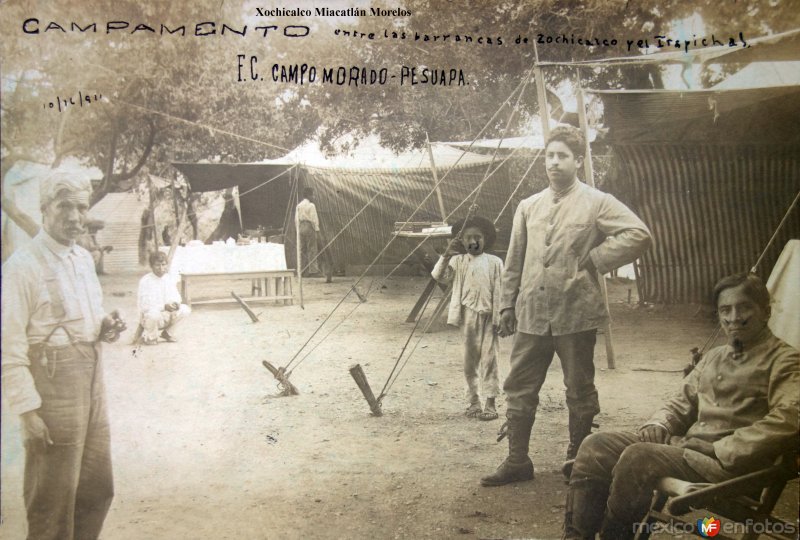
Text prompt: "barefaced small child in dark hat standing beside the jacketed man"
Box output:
[[431, 216, 503, 420]]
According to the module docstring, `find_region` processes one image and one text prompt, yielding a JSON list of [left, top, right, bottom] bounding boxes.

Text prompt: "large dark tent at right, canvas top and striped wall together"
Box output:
[[597, 86, 800, 303]]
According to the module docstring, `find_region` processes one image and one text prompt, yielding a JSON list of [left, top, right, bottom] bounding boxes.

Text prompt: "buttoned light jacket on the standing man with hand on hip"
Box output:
[[500, 181, 651, 336]]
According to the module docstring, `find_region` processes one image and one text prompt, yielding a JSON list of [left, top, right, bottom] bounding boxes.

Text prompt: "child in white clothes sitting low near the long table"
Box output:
[[138, 251, 192, 345]]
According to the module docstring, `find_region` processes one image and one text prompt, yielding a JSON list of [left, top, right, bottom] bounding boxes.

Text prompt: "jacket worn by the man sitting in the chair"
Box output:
[[647, 328, 800, 481]]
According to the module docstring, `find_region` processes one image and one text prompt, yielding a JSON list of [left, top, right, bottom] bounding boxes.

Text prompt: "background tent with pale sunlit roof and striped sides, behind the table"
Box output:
[[174, 140, 530, 267]]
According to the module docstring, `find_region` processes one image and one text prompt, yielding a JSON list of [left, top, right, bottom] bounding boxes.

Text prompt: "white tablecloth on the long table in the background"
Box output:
[[162, 243, 286, 276]]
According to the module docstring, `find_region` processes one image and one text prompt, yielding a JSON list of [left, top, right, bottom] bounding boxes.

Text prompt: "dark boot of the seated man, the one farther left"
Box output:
[[561, 480, 608, 540]]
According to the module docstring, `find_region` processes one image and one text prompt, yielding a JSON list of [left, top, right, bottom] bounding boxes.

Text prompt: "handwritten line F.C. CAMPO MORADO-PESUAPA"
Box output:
[[236, 54, 469, 86]]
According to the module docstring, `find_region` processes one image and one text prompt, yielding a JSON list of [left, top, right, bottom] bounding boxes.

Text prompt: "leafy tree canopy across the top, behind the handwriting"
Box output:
[[0, 0, 800, 226]]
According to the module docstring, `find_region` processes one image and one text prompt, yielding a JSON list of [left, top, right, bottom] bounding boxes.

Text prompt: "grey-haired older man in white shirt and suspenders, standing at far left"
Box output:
[[2, 172, 125, 540]]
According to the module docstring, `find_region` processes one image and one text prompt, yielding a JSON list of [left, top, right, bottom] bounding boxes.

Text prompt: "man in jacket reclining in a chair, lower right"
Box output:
[[564, 274, 800, 539]]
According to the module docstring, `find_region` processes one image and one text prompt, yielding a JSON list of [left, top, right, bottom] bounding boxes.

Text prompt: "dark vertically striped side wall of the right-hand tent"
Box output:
[[615, 144, 800, 303]]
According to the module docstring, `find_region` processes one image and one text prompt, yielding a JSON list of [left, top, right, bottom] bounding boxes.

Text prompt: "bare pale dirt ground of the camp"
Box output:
[[0, 274, 797, 540]]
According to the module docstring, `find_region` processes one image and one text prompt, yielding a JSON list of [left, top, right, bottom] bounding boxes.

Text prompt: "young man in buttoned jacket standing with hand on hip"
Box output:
[[481, 126, 650, 486]]
